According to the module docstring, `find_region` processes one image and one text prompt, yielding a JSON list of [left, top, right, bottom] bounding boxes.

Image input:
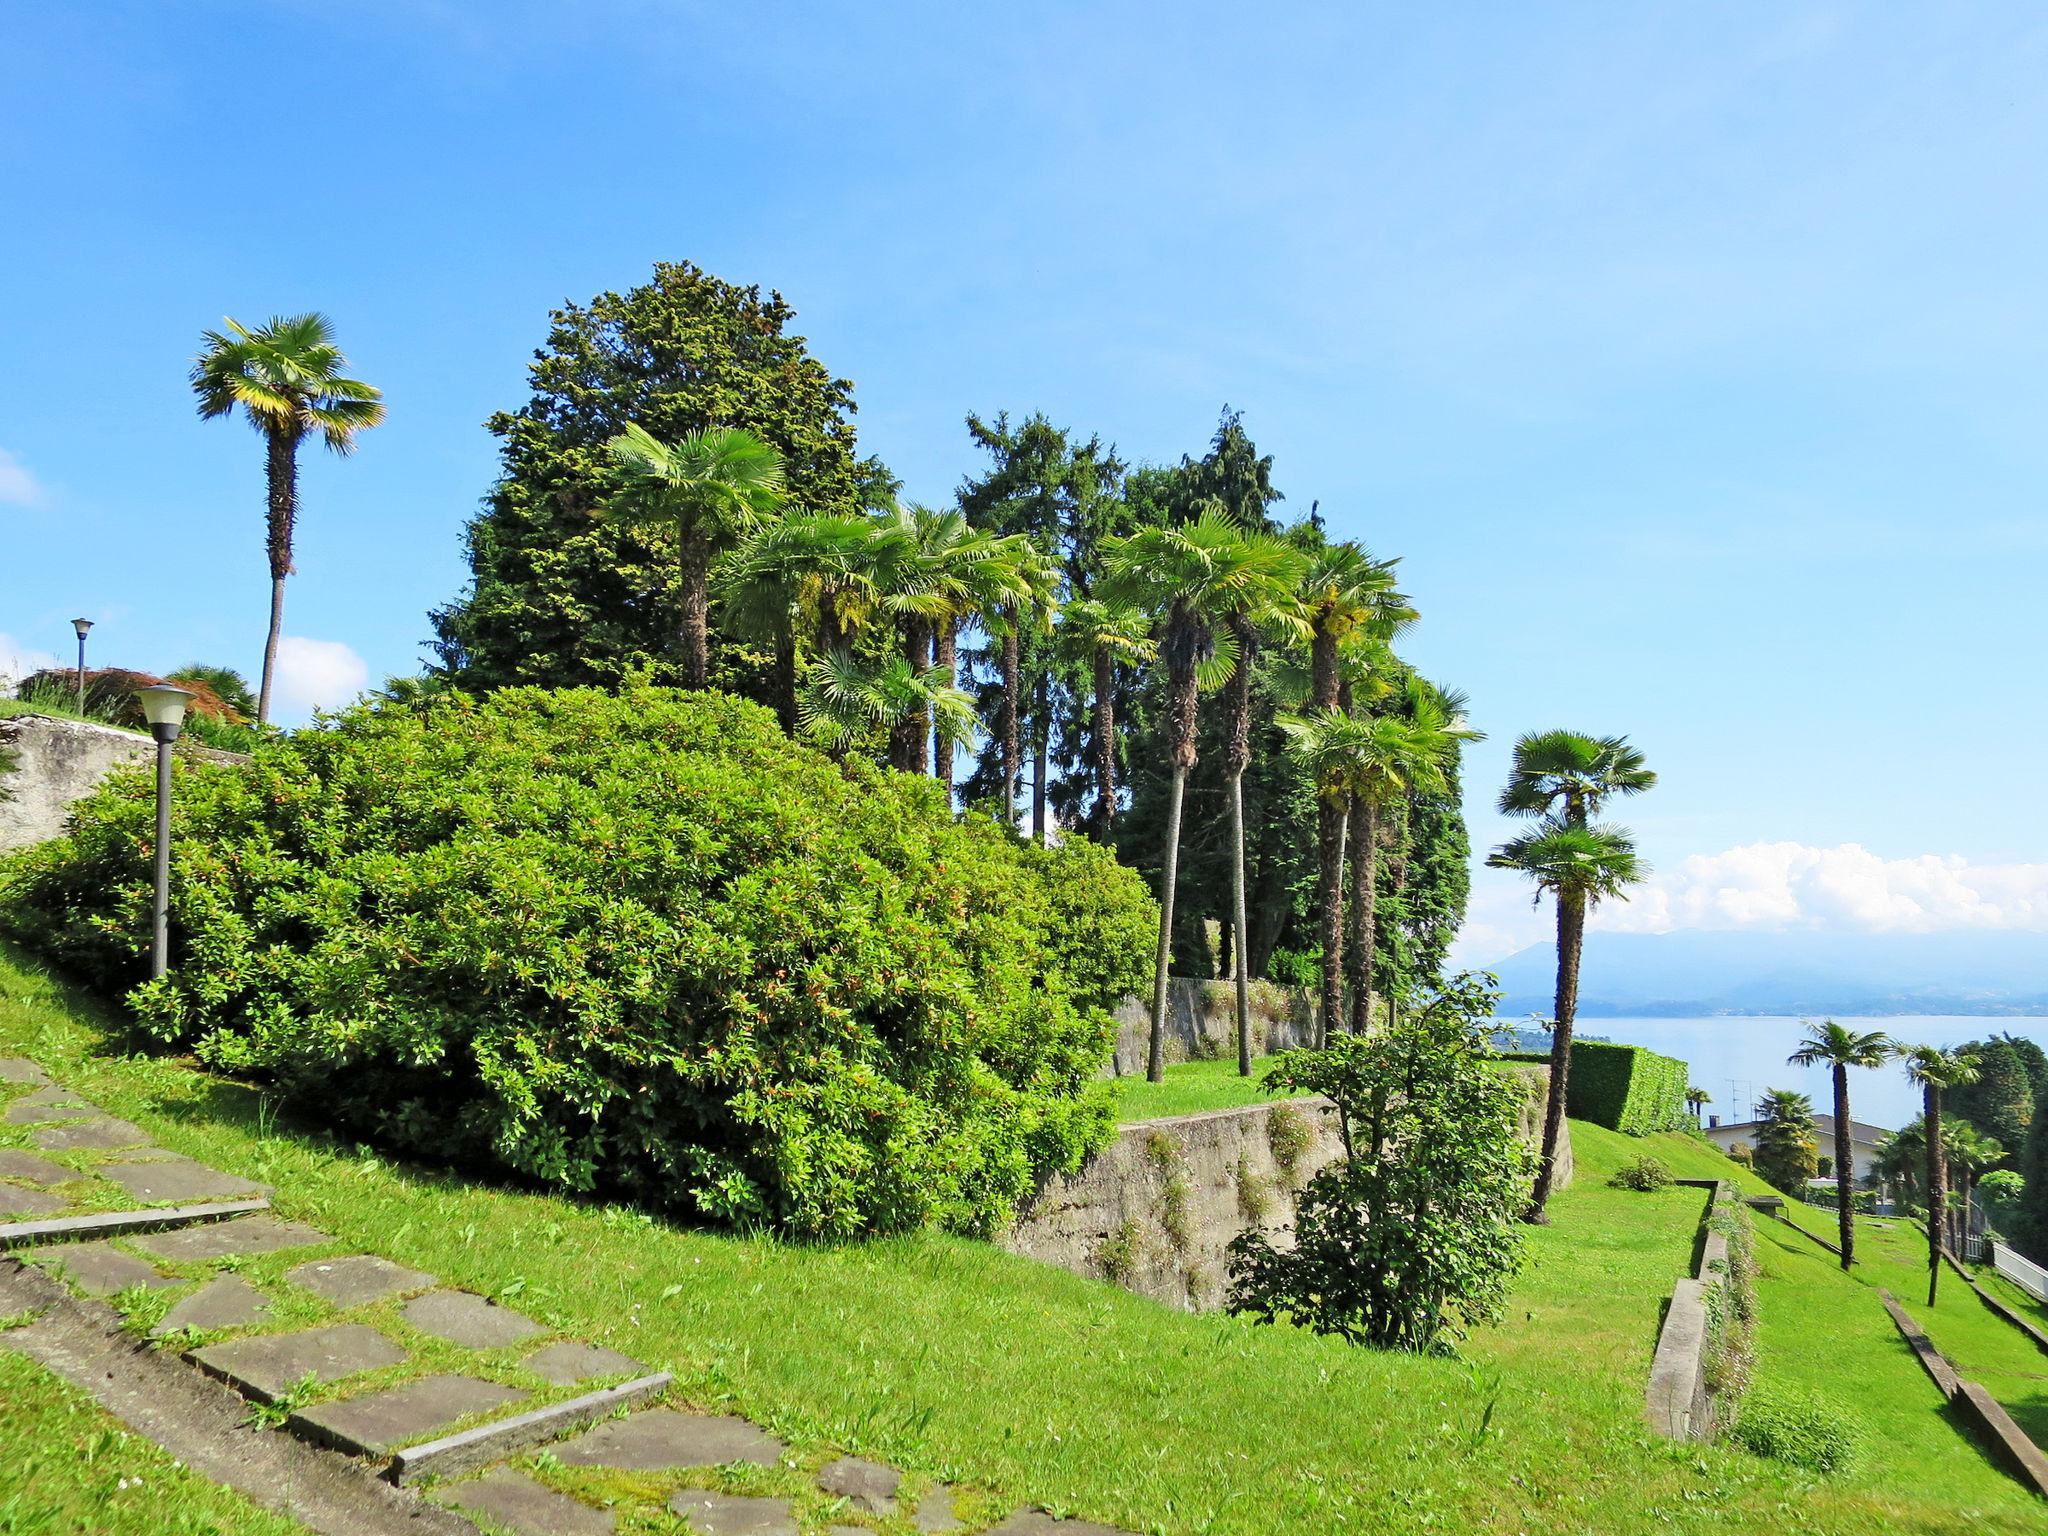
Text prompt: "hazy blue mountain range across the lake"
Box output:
[[1483, 930, 2048, 1018]]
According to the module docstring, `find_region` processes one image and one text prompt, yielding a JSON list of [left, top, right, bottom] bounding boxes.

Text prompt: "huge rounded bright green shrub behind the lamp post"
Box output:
[[0, 688, 1157, 1235]]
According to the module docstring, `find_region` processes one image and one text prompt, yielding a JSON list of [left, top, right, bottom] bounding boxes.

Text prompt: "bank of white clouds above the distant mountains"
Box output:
[[1458, 842, 2048, 965]]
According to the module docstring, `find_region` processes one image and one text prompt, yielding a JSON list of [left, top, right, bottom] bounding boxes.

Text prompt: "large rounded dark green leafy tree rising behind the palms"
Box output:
[[434, 262, 887, 696]]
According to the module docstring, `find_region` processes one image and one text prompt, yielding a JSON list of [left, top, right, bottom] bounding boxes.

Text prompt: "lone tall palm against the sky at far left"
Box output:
[[193, 313, 385, 725]]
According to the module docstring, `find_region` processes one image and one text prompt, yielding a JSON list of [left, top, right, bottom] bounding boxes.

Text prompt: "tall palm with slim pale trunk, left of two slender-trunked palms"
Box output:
[[1098, 502, 1300, 1081]]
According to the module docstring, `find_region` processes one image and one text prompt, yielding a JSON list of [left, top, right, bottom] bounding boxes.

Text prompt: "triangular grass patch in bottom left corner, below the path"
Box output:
[[0, 1331, 307, 1536]]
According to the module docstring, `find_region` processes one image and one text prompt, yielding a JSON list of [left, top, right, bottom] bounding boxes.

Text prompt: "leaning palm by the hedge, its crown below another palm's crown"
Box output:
[[1487, 817, 1649, 1223]]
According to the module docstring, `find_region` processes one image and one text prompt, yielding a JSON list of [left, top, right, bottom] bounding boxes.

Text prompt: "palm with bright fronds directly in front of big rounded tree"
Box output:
[[606, 422, 782, 688]]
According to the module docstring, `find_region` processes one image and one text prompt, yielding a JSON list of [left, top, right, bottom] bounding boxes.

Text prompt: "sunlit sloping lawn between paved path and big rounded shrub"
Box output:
[[0, 963, 2042, 1536]]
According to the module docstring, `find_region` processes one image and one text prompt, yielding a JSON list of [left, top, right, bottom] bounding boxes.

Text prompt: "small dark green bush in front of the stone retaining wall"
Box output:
[[1229, 979, 1534, 1352]]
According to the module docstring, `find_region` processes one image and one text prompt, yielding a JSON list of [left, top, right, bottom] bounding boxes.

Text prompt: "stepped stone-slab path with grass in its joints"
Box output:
[[0, 1057, 1120, 1536]]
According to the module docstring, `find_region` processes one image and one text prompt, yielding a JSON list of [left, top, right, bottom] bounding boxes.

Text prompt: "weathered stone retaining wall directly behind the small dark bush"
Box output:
[[1001, 1067, 1571, 1311]]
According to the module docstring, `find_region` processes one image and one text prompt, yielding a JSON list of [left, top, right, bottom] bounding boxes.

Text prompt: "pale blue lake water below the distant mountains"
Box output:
[[1540, 1014, 2048, 1130]]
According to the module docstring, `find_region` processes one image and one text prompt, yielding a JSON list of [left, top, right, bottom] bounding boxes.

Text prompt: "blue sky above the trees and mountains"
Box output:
[[0, 0, 2048, 958]]
